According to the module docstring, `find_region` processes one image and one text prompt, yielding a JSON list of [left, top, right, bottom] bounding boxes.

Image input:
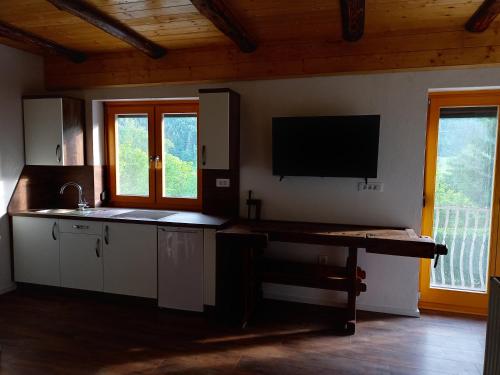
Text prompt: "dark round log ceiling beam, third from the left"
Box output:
[[191, 0, 257, 53]]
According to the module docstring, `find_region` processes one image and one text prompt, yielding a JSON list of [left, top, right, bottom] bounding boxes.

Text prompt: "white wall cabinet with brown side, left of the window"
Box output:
[[23, 98, 85, 165]]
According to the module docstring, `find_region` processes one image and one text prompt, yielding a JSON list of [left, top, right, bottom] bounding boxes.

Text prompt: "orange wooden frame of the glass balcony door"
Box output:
[[419, 90, 500, 315]]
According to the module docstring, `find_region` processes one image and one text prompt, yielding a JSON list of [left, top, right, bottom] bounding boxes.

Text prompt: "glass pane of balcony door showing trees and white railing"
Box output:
[[431, 107, 497, 292]]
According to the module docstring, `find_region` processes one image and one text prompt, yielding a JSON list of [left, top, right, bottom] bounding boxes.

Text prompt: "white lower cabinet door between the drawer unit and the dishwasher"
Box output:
[[103, 223, 157, 298]]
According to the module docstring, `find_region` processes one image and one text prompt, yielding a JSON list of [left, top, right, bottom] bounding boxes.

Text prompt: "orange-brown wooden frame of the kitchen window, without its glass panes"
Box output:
[[104, 100, 203, 211]]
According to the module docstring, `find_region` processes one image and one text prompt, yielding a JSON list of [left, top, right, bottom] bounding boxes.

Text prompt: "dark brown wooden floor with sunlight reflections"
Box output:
[[0, 289, 485, 375]]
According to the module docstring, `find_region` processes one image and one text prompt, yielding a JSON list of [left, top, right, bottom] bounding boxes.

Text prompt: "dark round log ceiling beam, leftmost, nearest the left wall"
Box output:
[[0, 21, 87, 63]]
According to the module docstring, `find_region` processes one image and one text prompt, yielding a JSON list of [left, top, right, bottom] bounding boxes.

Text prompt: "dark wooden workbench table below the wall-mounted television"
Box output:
[[216, 221, 448, 334]]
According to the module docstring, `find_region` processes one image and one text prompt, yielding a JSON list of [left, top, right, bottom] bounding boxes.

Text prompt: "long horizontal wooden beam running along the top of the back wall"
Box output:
[[45, 29, 500, 90]]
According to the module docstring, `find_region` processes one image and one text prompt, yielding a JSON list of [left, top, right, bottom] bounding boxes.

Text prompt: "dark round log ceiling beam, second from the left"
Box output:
[[47, 0, 167, 59]]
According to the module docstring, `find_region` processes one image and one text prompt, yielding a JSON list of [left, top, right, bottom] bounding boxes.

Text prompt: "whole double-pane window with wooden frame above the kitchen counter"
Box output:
[[106, 101, 201, 210]]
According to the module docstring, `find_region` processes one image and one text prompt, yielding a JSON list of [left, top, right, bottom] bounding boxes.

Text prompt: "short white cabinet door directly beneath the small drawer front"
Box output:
[[61, 233, 103, 291]]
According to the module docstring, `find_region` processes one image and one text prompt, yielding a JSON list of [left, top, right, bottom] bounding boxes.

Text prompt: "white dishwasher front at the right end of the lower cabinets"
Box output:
[[158, 227, 203, 312]]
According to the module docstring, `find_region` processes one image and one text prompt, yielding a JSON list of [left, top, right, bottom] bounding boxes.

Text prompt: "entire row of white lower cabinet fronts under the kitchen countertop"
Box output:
[[13, 216, 216, 306]]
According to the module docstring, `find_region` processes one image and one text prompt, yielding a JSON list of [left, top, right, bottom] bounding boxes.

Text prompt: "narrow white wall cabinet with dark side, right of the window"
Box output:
[[199, 89, 240, 170]]
